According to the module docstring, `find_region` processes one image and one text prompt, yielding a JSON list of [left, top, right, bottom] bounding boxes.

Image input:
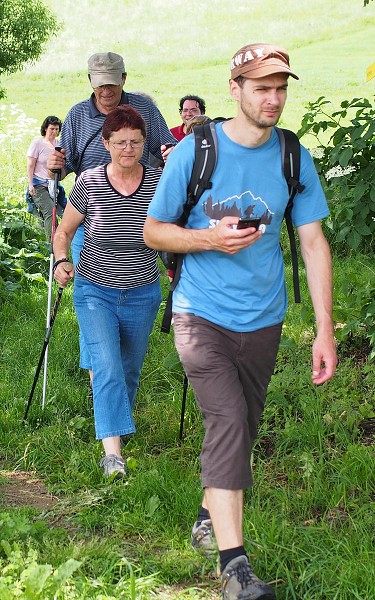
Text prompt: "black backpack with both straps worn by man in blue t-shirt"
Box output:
[[161, 119, 305, 333]]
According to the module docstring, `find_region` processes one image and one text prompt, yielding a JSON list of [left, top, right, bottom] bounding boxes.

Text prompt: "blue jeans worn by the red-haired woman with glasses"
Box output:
[[73, 273, 161, 440]]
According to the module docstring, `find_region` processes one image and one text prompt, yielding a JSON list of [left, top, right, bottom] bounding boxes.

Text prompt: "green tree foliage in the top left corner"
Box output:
[[0, 0, 60, 98]]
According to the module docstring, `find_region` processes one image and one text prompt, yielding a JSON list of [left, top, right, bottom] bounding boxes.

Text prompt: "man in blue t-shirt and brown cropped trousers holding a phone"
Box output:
[[144, 44, 337, 600]]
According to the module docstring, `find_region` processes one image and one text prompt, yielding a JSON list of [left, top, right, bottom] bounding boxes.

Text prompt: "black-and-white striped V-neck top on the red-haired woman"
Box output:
[[69, 165, 161, 289]]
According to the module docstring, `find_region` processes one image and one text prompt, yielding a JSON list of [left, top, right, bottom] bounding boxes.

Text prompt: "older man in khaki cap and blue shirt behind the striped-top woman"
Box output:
[[47, 52, 177, 393]]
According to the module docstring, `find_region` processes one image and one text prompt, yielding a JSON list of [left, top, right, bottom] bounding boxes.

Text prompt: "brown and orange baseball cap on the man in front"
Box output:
[[230, 44, 299, 79]]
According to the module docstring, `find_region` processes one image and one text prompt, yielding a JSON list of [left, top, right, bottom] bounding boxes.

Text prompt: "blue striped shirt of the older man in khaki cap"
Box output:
[[60, 92, 177, 175]]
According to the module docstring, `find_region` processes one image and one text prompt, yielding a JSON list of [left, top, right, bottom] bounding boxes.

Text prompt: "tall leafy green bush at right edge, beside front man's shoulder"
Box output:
[[298, 96, 375, 252]]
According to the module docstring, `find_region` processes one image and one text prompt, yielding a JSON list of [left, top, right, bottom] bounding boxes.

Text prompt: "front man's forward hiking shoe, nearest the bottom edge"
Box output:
[[221, 556, 276, 600]]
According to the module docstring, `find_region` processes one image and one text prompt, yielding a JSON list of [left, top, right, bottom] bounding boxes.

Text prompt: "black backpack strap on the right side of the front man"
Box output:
[[275, 127, 305, 304]]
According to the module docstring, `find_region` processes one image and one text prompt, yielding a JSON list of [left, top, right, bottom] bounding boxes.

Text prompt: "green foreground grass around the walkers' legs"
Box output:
[[0, 280, 375, 600]]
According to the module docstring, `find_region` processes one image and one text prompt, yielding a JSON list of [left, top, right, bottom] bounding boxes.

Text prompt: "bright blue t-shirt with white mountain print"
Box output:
[[148, 123, 329, 331]]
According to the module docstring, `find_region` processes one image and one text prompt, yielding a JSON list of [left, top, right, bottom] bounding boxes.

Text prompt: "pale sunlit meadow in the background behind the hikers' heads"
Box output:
[[4, 0, 375, 134]]
